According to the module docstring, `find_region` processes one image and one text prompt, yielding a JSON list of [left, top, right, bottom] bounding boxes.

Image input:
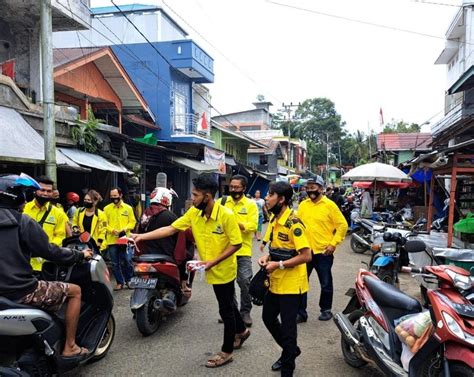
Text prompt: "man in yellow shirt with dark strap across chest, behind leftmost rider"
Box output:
[[23, 176, 67, 271]]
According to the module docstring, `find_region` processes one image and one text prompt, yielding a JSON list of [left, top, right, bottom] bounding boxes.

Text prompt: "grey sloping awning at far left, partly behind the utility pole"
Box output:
[[0, 106, 89, 171]]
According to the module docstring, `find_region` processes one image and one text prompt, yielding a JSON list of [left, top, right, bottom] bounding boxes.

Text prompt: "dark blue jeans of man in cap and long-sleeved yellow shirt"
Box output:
[[298, 254, 334, 319]]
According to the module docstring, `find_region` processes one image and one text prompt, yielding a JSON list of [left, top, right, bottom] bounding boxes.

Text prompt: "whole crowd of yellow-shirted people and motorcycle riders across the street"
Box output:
[[0, 174, 348, 376]]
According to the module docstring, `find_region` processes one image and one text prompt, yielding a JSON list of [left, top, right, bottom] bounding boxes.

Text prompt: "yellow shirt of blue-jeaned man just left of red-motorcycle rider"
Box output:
[[104, 201, 137, 246]]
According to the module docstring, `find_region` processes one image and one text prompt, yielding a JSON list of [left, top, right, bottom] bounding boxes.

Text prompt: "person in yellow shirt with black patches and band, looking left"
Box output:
[[258, 182, 311, 377]]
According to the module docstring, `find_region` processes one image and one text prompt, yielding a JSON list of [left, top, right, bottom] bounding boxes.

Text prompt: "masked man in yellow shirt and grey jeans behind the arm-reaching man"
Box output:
[[217, 175, 258, 327]]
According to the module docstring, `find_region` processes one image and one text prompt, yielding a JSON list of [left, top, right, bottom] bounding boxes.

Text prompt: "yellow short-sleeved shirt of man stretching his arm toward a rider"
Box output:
[[171, 203, 242, 284]]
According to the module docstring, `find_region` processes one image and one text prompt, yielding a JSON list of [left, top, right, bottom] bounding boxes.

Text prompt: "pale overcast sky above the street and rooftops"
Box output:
[[91, 0, 462, 133]]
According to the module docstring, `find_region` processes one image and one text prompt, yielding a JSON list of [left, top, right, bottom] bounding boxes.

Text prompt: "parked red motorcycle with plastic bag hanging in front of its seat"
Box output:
[[334, 258, 474, 377]]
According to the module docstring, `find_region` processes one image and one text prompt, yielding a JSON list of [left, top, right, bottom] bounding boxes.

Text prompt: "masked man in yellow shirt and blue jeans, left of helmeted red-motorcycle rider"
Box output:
[[104, 187, 137, 291]]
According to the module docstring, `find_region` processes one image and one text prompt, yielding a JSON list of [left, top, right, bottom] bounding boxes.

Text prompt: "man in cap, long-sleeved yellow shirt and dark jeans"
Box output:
[[297, 176, 347, 322]]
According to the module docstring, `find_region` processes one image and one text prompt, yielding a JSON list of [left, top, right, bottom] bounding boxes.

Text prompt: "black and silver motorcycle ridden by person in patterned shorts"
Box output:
[[0, 233, 115, 376]]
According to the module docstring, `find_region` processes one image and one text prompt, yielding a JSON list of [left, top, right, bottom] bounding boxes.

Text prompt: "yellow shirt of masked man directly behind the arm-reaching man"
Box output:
[[217, 195, 258, 257]]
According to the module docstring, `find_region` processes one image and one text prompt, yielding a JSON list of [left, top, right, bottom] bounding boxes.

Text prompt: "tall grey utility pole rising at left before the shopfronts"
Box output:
[[40, 0, 57, 184]]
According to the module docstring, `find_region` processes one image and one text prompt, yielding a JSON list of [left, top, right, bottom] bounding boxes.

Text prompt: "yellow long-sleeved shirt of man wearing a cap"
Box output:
[[298, 196, 348, 254]]
